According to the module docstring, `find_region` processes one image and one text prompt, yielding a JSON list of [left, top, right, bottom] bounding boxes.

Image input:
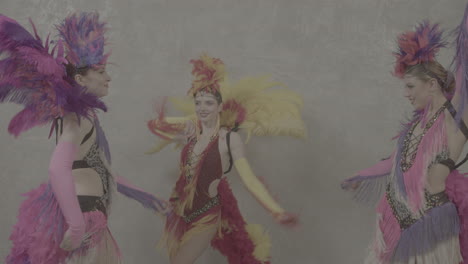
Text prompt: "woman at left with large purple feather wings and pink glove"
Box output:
[[0, 13, 165, 264]]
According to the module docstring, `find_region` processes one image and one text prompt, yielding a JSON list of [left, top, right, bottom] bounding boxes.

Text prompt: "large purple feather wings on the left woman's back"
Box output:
[[0, 14, 106, 136]]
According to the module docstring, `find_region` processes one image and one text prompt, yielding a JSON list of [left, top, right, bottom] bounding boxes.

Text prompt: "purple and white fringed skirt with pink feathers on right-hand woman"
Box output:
[[365, 171, 468, 264]]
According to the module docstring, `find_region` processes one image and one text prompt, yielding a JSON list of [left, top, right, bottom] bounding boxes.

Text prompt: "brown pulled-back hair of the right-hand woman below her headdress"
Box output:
[[405, 61, 455, 94]]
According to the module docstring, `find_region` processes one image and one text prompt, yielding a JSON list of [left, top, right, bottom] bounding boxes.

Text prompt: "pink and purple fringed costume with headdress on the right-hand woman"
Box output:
[[342, 11, 468, 264]]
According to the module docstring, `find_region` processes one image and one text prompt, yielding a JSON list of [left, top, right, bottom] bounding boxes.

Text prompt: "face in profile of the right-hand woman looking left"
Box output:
[[403, 75, 431, 110]]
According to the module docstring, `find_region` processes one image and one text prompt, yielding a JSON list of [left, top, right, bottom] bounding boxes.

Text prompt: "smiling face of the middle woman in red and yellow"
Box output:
[[195, 92, 222, 122]]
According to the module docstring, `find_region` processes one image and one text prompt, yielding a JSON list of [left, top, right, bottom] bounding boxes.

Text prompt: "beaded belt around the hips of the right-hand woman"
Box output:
[[386, 184, 449, 230]]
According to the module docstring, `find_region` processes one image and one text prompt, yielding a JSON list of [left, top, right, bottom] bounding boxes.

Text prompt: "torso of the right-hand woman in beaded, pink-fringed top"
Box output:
[[385, 103, 466, 229]]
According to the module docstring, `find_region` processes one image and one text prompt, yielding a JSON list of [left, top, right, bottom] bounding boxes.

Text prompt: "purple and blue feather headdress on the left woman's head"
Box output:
[[57, 12, 110, 68]]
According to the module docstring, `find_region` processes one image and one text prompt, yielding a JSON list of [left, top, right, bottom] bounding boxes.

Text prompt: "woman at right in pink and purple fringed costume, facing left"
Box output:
[[342, 9, 468, 264]]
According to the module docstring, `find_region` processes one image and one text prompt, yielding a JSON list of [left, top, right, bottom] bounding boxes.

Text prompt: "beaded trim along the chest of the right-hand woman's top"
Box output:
[[400, 103, 447, 172]]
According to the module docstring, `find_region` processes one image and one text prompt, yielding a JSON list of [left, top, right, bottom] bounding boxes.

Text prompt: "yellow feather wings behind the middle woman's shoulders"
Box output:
[[165, 76, 307, 141]]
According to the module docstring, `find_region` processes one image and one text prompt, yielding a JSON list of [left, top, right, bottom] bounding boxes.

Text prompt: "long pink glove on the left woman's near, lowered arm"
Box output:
[[49, 142, 85, 249]]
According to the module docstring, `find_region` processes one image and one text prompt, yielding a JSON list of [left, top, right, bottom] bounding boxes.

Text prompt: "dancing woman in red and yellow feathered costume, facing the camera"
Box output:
[[148, 55, 305, 264]]
